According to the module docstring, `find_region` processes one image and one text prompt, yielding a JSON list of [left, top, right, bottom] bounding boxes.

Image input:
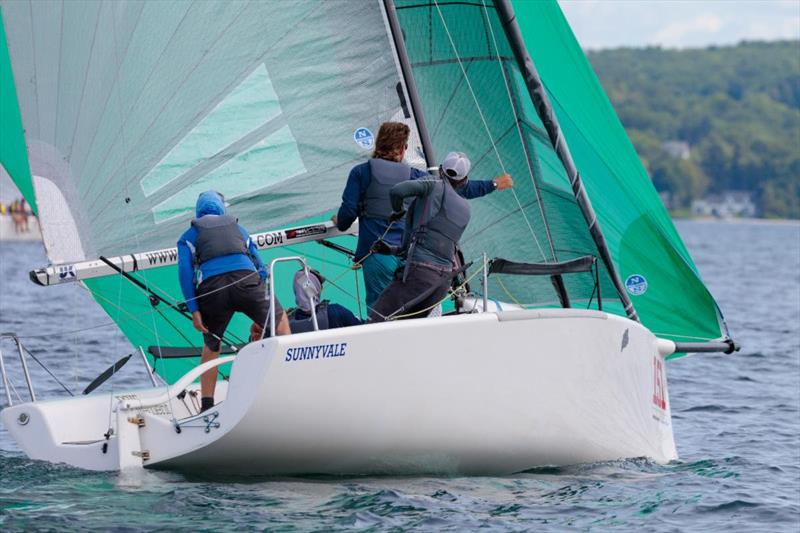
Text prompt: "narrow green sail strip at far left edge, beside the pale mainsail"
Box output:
[[0, 7, 37, 213]]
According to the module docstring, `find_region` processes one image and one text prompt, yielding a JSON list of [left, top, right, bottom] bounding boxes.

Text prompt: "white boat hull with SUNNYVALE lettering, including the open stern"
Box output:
[[2, 309, 677, 475]]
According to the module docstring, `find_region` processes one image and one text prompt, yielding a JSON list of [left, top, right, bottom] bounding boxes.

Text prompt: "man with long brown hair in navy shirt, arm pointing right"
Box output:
[[332, 122, 514, 307]]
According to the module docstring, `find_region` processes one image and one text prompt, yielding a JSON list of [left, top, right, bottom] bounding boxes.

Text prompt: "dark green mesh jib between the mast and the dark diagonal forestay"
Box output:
[[395, 0, 624, 314]]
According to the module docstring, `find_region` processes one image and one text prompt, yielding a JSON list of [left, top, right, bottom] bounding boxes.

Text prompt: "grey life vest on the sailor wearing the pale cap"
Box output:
[[408, 179, 470, 261]]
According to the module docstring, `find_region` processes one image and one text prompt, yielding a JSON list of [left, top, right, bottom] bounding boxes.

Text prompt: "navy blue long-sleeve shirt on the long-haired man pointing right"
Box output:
[[336, 161, 494, 260]]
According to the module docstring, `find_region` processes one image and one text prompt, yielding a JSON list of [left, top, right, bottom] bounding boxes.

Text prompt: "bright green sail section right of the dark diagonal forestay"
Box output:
[[513, 0, 725, 341]]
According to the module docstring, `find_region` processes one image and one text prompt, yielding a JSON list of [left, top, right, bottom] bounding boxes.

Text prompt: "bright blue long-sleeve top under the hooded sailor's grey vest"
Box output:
[[178, 223, 267, 313]]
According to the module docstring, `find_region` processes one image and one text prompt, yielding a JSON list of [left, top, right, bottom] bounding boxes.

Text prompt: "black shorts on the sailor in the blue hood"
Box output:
[[197, 270, 283, 352]]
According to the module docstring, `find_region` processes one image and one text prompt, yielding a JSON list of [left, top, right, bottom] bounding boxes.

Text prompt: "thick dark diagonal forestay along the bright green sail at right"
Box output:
[[494, 0, 639, 322]]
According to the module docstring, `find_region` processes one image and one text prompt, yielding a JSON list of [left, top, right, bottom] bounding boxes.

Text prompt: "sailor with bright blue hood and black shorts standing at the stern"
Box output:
[[178, 191, 291, 411]]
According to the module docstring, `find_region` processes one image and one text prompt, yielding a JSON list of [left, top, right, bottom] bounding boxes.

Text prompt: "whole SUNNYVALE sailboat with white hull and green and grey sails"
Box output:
[[0, 0, 736, 475]]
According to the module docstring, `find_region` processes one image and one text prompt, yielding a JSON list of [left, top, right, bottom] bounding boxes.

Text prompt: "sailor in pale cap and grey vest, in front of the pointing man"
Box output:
[[369, 152, 471, 322]]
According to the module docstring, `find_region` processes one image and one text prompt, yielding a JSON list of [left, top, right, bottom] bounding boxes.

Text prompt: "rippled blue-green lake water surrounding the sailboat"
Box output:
[[0, 222, 800, 533]]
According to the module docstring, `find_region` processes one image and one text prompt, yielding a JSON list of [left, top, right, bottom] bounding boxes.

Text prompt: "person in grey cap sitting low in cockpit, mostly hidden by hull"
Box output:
[[288, 270, 361, 333]]
